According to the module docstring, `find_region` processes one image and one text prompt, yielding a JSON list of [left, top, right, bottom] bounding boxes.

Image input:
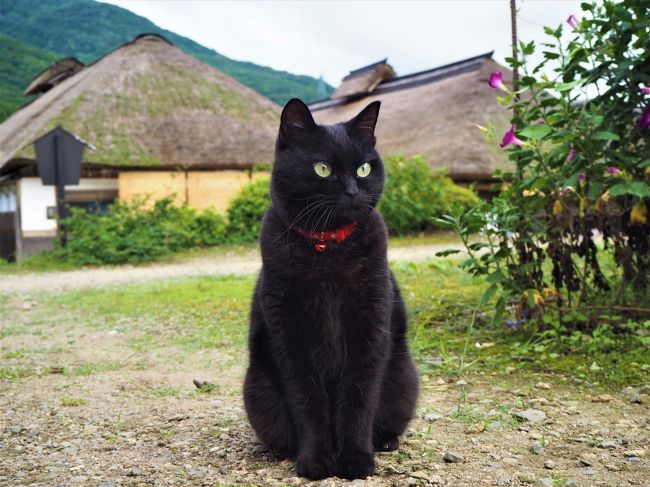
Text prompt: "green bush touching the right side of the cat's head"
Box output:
[[378, 156, 479, 234]]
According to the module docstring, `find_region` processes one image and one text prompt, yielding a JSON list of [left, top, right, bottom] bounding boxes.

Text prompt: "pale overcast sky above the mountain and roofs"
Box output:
[[104, 0, 580, 86]]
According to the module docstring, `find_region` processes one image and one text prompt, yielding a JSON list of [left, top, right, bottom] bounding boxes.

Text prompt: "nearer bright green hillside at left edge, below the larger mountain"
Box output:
[[0, 35, 61, 122]]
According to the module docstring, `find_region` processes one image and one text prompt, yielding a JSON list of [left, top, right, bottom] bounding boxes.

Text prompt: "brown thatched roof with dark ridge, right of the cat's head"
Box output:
[[309, 53, 512, 181]]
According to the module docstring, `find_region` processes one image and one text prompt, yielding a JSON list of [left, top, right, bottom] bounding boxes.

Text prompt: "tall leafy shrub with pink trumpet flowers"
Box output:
[[441, 0, 650, 327]]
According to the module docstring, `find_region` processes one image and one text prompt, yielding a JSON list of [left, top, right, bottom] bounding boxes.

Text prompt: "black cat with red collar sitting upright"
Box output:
[[244, 99, 418, 479]]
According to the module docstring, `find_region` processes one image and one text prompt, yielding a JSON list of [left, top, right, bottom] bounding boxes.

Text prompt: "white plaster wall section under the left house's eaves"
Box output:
[[18, 178, 56, 232]]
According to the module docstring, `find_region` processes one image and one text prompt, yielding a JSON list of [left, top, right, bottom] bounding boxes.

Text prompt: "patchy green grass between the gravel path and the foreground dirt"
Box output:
[[0, 258, 650, 388]]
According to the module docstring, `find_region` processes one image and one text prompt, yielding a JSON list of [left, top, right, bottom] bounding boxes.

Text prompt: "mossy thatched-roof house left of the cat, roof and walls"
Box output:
[[0, 34, 280, 260]]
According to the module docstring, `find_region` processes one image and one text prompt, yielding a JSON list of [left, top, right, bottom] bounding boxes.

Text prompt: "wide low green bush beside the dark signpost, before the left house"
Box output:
[[55, 197, 226, 265]]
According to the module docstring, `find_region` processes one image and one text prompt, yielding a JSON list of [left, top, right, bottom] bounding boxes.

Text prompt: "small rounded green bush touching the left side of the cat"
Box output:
[[227, 177, 271, 243]]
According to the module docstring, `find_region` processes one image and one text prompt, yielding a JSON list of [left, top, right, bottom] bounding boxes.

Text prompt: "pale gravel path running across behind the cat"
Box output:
[[0, 244, 460, 293]]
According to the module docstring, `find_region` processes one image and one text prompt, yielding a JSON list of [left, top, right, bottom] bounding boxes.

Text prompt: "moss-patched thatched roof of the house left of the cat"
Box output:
[[0, 34, 280, 172]]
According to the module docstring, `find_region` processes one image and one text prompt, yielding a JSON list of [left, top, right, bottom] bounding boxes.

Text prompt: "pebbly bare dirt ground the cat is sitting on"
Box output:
[[0, 262, 650, 487]]
